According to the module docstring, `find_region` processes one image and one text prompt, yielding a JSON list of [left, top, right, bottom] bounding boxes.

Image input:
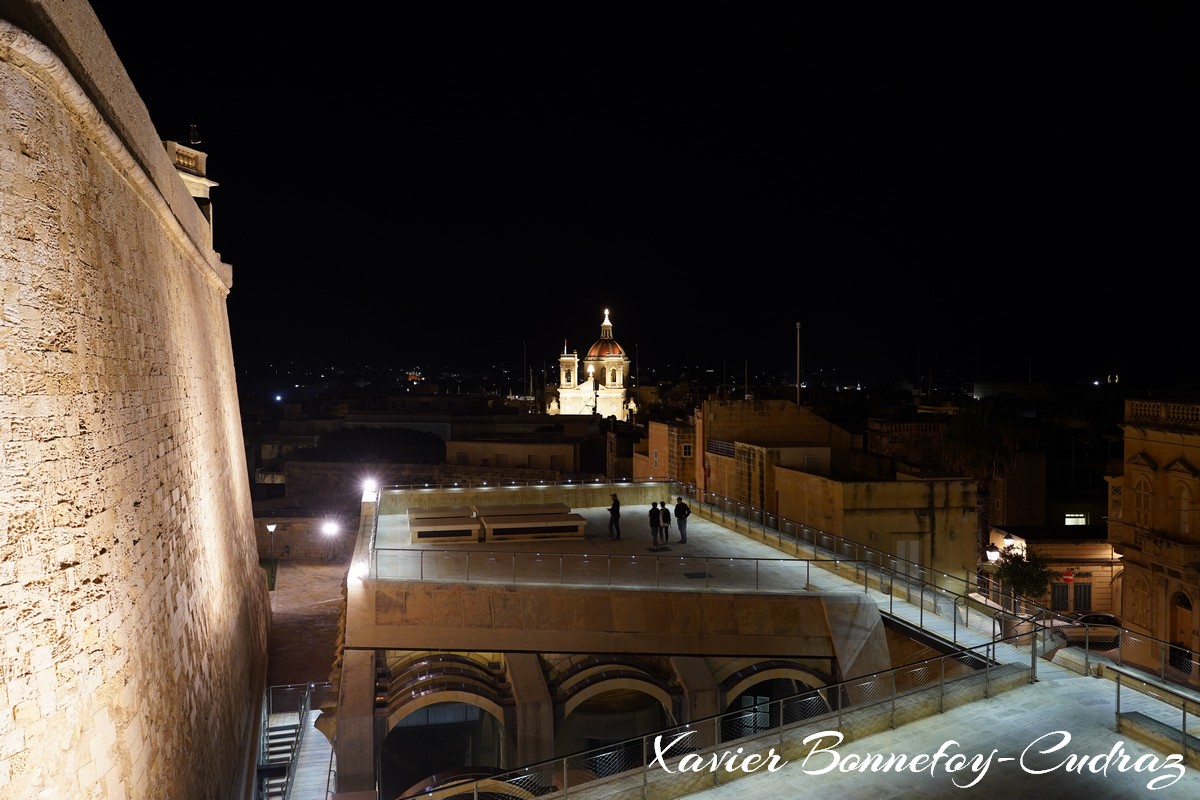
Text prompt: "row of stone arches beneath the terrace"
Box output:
[[376, 625, 964, 798]]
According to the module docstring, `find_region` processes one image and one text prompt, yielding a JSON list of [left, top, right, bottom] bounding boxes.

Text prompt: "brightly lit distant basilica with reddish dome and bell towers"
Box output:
[[546, 308, 637, 421]]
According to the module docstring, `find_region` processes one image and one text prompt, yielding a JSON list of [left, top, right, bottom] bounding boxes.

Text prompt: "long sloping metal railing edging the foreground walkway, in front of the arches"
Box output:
[[393, 639, 1028, 800]]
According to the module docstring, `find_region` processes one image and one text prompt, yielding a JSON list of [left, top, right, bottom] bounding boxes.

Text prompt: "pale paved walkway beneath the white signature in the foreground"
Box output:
[[690, 675, 1200, 800]]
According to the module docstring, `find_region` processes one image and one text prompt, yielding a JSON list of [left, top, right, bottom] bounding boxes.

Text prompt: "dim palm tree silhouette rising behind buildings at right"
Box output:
[[942, 397, 1016, 559]]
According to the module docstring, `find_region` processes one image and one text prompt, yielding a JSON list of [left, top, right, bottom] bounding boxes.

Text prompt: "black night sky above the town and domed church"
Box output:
[[94, 0, 1200, 393]]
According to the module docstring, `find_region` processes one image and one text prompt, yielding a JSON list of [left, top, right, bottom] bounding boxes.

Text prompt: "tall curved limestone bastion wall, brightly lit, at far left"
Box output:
[[0, 0, 270, 800]]
